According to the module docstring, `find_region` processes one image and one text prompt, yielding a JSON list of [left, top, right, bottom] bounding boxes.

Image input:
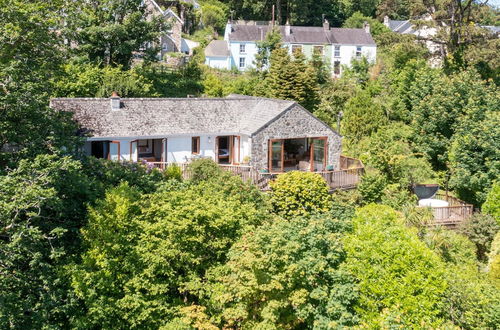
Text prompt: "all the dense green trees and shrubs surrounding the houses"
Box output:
[[0, 0, 500, 329]]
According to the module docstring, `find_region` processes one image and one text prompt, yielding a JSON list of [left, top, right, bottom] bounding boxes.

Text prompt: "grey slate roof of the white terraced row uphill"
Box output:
[[229, 24, 375, 45]]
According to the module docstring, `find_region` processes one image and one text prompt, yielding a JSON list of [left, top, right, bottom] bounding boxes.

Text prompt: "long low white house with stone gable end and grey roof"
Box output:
[[51, 95, 341, 173]]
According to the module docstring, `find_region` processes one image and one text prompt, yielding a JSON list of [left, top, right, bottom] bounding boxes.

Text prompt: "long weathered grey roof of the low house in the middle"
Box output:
[[51, 95, 300, 138]]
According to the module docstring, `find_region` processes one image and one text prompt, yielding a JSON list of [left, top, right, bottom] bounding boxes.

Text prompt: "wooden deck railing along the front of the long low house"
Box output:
[[147, 156, 364, 191]]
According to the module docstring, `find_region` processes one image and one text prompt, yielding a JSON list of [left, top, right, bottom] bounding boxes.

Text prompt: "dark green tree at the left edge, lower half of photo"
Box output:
[[0, 155, 96, 329]]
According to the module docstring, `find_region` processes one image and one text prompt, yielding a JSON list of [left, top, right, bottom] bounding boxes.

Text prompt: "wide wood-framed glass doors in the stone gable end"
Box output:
[[269, 137, 327, 173]]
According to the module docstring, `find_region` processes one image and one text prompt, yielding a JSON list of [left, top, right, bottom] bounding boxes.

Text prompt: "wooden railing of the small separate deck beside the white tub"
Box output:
[[422, 191, 474, 228]]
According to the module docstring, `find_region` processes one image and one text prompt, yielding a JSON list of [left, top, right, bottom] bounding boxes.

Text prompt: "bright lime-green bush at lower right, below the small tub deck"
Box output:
[[343, 205, 446, 328]]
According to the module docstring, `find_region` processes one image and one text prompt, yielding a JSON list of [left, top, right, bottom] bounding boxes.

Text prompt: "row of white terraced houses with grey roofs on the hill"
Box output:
[[205, 20, 377, 76]]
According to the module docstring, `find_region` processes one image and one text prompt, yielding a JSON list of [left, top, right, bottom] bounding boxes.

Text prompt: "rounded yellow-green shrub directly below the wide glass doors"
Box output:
[[270, 171, 331, 216]]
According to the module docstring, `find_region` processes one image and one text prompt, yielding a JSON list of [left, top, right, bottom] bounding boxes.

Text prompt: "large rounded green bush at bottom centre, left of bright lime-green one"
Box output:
[[209, 214, 357, 329]]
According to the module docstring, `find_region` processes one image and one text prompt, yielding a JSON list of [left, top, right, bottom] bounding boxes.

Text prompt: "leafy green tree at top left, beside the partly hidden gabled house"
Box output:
[[65, 0, 166, 68]]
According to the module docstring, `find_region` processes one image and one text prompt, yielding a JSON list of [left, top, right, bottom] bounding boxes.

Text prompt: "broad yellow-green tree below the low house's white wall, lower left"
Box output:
[[72, 173, 268, 328]]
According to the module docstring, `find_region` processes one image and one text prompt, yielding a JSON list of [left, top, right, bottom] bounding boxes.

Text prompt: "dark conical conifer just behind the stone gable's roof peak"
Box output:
[[263, 48, 319, 111]]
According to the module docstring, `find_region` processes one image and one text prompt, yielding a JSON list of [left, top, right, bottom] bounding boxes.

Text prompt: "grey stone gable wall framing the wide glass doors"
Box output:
[[250, 105, 342, 170]]
